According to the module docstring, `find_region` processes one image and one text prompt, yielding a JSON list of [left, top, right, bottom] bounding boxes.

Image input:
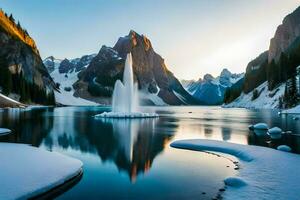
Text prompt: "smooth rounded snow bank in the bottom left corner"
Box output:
[[0, 143, 82, 199]]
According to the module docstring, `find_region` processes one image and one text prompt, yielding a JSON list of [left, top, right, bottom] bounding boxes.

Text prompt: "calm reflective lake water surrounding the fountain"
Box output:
[[0, 106, 300, 199]]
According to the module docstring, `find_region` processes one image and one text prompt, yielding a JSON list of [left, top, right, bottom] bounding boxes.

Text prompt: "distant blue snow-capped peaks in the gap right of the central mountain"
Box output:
[[182, 69, 244, 105]]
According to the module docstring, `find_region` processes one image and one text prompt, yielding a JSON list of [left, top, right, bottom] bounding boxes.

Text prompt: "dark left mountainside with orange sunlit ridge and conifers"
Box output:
[[0, 10, 55, 104]]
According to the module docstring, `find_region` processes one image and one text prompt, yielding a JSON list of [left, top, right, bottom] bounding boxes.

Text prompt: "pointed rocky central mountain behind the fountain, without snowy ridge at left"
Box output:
[[74, 31, 199, 105]]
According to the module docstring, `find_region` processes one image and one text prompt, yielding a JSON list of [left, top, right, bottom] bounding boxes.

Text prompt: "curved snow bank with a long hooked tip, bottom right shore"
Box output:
[[171, 139, 300, 200]]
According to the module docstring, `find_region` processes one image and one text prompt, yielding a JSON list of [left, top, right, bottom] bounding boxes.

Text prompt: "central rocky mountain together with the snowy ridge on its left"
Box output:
[[44, 31, 200, 105]]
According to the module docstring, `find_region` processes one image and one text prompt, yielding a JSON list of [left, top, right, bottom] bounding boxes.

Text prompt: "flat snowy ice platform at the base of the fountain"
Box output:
[[95, 112, 158, 119]]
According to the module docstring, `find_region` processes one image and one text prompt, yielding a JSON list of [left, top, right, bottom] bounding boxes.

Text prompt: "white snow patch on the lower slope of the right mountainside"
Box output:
[[223, 81, 285, 109]]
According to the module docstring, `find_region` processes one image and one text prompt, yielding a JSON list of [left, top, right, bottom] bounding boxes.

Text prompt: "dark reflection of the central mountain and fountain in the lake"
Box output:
[[37, 109, 173, 182]]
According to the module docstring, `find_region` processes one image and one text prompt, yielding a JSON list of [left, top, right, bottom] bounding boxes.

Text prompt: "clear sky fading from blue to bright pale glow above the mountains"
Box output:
[[0, 0, 300, 80]]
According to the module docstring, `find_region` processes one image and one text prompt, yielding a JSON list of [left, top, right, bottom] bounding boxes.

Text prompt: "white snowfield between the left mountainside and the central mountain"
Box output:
[[51, 69, 98, 106]]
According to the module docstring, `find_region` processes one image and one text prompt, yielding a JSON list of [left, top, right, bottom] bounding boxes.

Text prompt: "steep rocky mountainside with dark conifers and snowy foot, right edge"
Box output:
[[225, 7, 300, 108]]
